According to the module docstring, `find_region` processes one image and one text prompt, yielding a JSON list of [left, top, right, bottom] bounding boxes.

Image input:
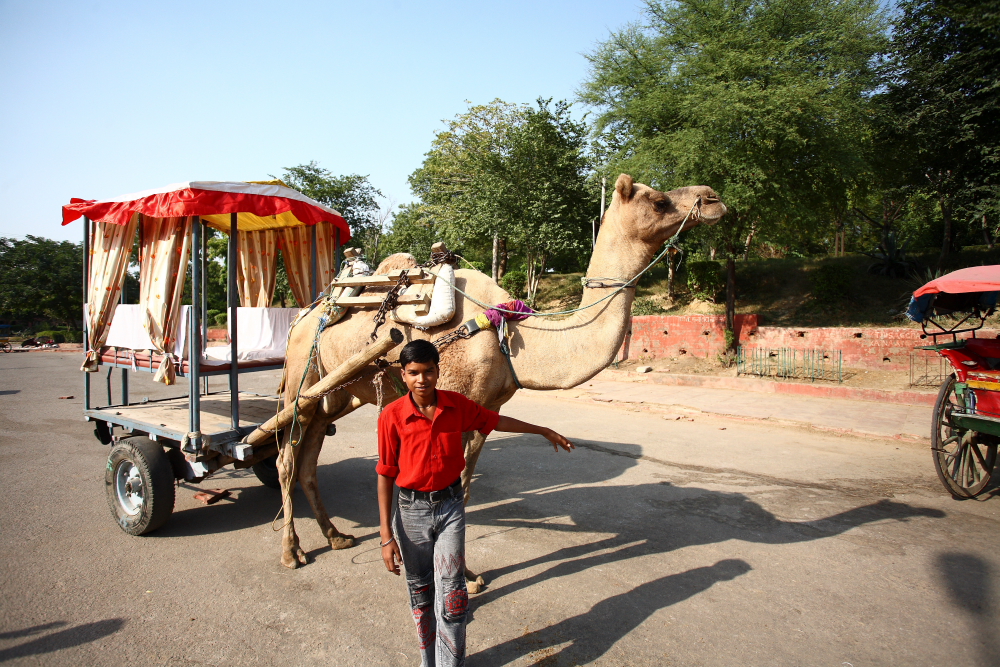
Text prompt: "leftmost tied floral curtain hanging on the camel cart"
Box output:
[[80, 214, 139, 373]]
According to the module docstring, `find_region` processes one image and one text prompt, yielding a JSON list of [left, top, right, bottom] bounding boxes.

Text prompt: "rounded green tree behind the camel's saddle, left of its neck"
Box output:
[[410, 99, 594, 298]]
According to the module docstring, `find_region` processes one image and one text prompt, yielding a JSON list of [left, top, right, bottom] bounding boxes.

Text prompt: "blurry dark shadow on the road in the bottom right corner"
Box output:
[[935, 552, 1000, 667]]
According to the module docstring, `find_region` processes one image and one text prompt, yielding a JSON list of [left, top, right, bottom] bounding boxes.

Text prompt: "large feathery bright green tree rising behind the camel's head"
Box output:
[[581, 0, 885, 342]]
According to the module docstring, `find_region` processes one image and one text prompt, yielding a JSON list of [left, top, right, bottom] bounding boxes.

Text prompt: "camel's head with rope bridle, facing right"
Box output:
[[609, 174, 726, 246]]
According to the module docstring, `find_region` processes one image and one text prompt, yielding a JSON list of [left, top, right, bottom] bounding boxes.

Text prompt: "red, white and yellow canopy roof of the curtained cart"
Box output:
[[62, 181, 351, 243]]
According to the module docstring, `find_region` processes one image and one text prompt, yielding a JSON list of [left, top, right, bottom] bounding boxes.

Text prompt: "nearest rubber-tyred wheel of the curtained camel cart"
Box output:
[[104, 437, 174, 535]]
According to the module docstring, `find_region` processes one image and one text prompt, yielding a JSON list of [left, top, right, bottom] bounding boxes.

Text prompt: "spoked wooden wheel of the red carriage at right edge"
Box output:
[[931, 376, 997, 498]]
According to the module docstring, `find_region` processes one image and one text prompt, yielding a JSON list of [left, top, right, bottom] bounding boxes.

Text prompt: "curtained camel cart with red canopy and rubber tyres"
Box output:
[[63, 181, 380, 535]]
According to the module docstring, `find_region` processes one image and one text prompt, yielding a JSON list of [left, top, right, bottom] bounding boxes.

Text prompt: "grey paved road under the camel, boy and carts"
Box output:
[[0, 353, 1000, 667]]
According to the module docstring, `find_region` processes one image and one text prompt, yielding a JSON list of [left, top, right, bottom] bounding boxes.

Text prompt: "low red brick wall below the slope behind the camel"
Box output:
[[620, 315, 1000, 370]]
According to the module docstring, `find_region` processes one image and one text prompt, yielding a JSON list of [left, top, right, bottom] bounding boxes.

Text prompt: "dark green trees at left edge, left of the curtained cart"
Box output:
[[0, 235, 83, 328]]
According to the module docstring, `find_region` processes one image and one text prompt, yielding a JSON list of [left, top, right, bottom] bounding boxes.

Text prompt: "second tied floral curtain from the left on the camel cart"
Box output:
[[139, 217, 192, 385]]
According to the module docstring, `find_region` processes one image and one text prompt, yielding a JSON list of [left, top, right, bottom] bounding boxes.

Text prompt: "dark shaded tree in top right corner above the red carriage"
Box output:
[[880, 0, 1000, 262]]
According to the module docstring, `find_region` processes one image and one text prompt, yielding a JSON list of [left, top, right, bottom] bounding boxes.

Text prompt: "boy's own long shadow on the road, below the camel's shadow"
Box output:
[[471, 559, 752, 665]]
